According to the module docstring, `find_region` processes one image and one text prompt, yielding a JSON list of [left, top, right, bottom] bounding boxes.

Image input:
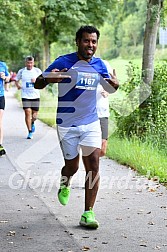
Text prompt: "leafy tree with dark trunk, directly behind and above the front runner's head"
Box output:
[[40, 0, 117, 68]]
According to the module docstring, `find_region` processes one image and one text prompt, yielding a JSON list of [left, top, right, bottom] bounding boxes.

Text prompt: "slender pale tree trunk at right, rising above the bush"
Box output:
[[142, 0, 163, 84]]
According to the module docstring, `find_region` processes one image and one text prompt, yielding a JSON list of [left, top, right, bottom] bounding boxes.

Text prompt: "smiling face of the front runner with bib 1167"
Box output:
[[77, 32, 98, 62]]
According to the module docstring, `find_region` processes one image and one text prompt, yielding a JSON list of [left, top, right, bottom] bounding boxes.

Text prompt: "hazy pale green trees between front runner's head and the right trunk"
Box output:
[[100, 0, 147, 58]]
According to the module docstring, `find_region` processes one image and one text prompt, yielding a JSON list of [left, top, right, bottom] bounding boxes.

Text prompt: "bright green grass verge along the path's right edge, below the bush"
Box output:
[[107, 135, 167, 183]]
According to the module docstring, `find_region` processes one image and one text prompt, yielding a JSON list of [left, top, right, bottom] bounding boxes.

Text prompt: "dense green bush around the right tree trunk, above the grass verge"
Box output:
[[114, 62, 167, 152]]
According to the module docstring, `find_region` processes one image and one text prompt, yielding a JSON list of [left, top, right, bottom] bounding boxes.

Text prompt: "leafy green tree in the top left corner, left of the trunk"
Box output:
[[0, 0, 43, 71]]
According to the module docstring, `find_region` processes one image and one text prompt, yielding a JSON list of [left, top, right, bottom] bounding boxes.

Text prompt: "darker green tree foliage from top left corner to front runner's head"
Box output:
[[0, 0, 117, 69]]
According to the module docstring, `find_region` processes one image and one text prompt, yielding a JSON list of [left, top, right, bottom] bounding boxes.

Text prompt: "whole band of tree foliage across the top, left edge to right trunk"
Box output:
[[0, 0, 166, 68]]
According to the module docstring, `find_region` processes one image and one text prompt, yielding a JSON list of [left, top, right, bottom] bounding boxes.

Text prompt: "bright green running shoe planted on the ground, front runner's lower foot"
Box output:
[[79, 208, 99, 229]]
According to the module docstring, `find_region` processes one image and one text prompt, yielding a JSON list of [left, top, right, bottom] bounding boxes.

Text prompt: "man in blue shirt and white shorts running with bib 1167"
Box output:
[[35, 26, 118, 229]]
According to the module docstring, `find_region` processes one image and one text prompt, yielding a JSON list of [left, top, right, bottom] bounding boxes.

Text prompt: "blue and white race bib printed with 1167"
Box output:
[[75, 72, 99, 90]]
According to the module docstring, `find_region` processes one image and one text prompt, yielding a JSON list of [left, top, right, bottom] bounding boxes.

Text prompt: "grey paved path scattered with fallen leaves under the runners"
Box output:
[[0, 90, 167, 252]]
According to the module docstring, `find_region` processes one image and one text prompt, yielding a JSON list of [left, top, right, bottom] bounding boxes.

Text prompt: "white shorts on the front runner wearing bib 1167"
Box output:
[[57, 120, 101, 160]]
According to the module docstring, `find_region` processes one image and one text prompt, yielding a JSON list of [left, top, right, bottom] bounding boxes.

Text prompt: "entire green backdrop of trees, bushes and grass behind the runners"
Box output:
[[0, 0, 167, 183]]
